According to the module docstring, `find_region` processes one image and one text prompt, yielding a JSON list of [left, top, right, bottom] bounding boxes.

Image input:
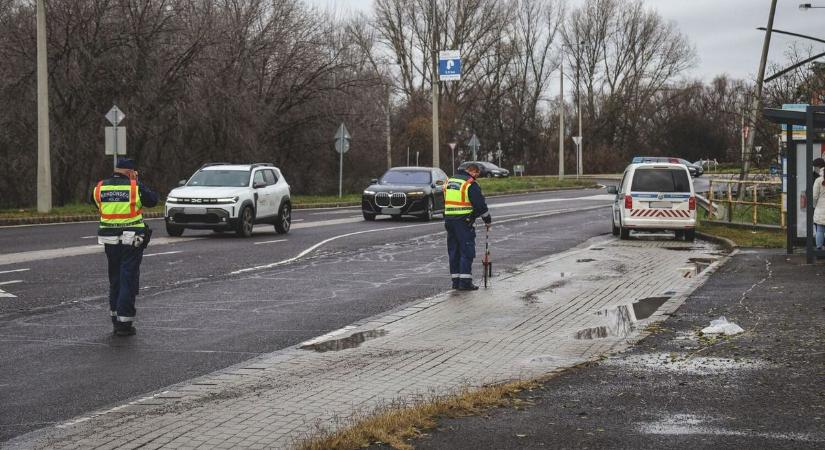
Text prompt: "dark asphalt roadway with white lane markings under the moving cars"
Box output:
[[0, 186, 609, 442]]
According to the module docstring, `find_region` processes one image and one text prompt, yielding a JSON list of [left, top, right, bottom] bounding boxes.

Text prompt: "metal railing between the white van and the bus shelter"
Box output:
[[707, 179, 787, 229]]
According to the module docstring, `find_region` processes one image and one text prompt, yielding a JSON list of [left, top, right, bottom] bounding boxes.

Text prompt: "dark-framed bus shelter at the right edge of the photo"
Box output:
[[763, 105, 825, 264]]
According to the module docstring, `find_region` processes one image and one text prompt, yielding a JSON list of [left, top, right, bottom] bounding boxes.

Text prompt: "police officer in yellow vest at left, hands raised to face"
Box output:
[[92, 158, 158, 336]]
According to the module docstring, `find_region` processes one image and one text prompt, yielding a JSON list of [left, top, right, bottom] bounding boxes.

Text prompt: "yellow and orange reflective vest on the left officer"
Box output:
[[95, 180, 146, 228]]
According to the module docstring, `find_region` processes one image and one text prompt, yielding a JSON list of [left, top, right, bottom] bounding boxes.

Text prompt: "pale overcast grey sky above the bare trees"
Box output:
[[305, 0, 825, 81]]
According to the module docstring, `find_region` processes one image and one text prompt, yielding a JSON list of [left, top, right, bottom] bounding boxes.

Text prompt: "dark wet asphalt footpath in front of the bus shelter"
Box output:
[[402, 251, 825, 449]]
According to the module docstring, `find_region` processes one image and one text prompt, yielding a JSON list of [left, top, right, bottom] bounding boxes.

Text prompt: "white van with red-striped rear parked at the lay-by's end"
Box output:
[[607, 163, 696, 242]]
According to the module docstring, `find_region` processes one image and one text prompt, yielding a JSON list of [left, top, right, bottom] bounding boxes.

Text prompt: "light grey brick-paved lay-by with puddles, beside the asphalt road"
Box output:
[[6, 238, 725, 448]]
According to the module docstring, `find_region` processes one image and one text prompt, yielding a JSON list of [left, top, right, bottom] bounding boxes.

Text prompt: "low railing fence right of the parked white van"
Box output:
[[707, 179, 787, 229]]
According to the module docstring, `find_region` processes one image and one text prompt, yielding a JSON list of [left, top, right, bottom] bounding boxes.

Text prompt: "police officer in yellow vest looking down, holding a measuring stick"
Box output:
[[444, 164, 493, 291]]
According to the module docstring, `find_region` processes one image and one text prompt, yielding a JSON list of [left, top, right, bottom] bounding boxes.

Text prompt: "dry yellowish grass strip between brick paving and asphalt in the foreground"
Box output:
[[298, 381, 539, 450]]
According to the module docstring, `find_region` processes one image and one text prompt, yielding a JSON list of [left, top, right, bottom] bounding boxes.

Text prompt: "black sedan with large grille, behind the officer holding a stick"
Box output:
[[361, 167, 448, 220]]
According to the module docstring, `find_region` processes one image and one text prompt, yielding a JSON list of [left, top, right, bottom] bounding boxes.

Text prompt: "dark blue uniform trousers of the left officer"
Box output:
[[106, 244, 143, 325]]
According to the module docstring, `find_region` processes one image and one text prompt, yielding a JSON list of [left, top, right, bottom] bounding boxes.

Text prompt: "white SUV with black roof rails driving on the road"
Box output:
[[164, 163, 292, 237]]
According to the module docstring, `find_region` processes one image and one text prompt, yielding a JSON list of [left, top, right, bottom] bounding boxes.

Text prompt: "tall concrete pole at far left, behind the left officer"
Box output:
[[37, 0, 52, 212]]
